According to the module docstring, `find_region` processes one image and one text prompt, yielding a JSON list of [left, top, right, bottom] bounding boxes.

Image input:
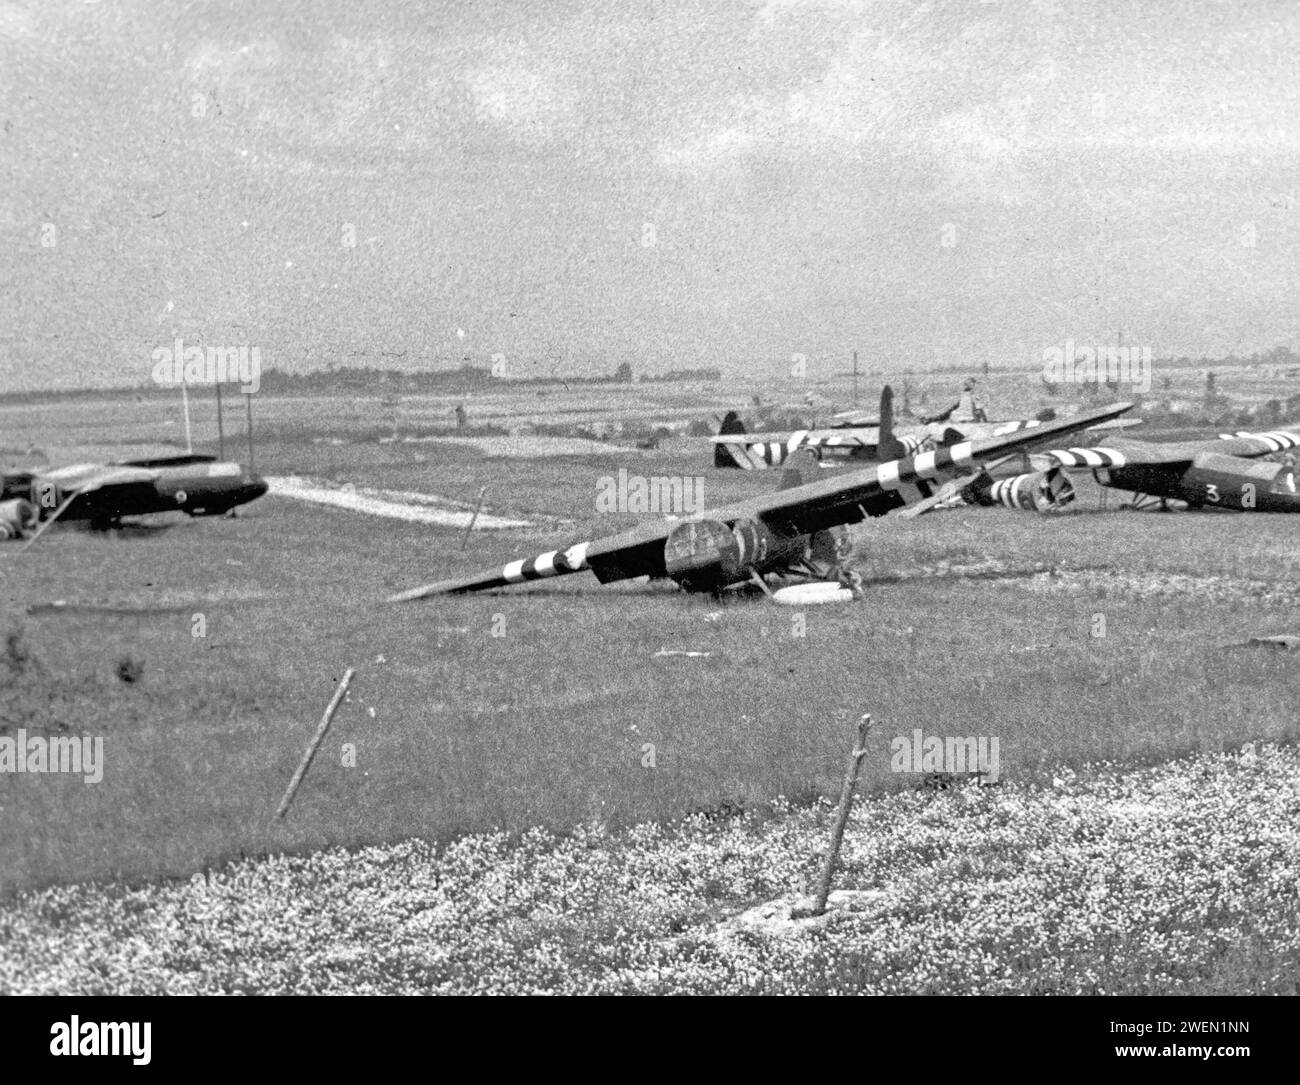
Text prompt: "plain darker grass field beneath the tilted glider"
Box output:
[[0, 387, 1300, 992]]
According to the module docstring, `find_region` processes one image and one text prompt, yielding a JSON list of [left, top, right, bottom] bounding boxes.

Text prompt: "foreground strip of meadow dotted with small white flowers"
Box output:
[[0, 745, 1300, 994]]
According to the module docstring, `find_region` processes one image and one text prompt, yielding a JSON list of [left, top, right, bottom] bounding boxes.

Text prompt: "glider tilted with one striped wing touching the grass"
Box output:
[[389, 403, 1132, 602]]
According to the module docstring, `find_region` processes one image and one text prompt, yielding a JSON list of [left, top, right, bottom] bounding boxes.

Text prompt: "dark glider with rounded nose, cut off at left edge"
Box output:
[[0, 455, 267, 544]]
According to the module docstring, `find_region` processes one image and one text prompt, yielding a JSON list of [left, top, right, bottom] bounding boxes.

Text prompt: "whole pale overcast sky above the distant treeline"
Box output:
[[0, 0, 1300, 389]]
